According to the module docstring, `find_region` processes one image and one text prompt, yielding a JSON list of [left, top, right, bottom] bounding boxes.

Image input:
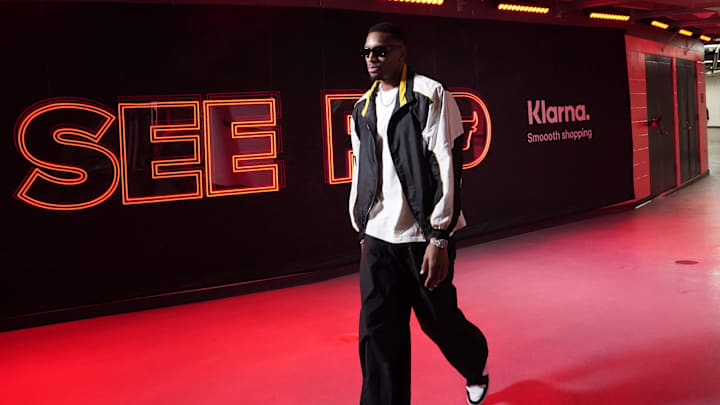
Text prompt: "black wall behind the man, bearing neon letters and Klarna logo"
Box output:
[[0, 4, 633, 318]]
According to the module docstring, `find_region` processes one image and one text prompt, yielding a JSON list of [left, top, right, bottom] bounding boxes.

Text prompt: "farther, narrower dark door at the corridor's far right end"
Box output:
[[676, 59, 700, 183]]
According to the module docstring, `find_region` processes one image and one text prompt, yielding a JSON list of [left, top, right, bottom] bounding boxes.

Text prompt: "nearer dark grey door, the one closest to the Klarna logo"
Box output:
[[645, 55, 675, 196]]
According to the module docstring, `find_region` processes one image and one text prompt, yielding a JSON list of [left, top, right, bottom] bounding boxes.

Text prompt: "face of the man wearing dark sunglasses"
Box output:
[[365, 32, 407, 81]]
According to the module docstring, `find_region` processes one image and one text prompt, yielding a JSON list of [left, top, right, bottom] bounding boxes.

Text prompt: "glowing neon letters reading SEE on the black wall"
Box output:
[[15, 93, 282, 210]]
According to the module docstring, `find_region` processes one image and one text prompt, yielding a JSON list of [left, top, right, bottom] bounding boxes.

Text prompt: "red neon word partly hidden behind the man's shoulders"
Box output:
[[323, 89, 492, 184]]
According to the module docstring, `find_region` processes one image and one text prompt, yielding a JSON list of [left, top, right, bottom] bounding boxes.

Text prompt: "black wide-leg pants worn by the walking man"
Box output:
[[359, 235, 488, 405]]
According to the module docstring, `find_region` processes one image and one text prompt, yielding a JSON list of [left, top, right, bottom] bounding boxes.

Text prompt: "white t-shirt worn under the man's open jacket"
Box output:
[[365, 87, 425, 243]]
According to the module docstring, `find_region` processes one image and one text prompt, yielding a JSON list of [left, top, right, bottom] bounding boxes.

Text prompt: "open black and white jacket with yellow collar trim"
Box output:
[[349, 66, 465, 239]]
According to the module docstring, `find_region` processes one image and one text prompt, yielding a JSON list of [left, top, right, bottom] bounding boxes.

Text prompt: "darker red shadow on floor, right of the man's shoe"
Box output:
[[484, 336, 720, 405]]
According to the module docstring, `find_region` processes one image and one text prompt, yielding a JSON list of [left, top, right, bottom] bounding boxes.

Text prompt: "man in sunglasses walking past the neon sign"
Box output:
[[349, 23, 489, 405]]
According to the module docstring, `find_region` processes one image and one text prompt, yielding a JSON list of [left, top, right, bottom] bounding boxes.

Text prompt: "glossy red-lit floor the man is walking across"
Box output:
[[0, 130, 720, 405]]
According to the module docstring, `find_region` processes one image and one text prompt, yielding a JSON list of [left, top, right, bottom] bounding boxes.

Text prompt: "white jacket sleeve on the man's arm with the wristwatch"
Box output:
[[423, 87, 463, 239]]
